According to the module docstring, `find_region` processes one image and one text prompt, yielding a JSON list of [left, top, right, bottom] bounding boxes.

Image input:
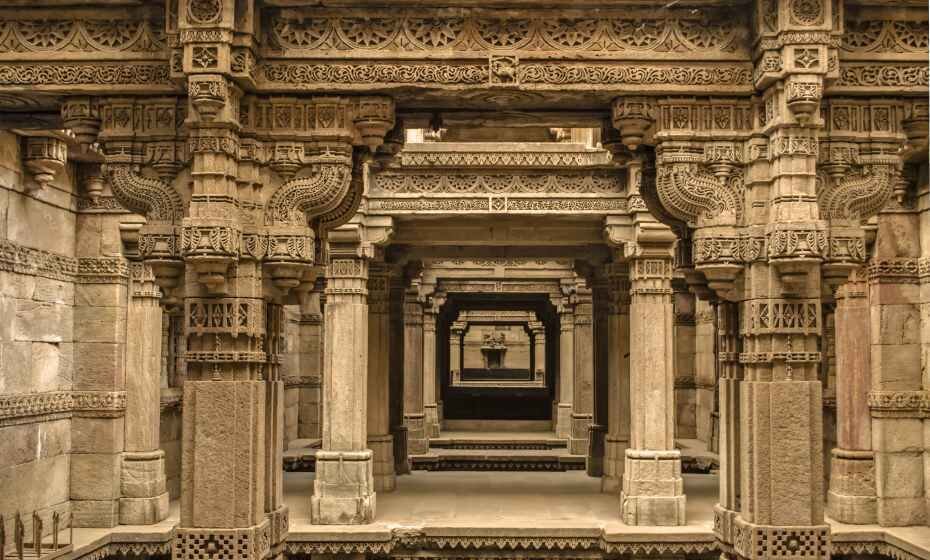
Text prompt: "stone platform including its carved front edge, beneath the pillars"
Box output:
[[68, 471, 930, 560]]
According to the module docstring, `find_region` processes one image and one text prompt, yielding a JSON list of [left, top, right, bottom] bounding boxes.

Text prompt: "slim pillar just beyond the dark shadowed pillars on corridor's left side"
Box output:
[[404, 279, 429, 455]]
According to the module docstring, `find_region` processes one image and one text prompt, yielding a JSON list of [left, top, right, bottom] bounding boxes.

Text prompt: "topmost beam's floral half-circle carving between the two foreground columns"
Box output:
[[270, 12, 744, 52]]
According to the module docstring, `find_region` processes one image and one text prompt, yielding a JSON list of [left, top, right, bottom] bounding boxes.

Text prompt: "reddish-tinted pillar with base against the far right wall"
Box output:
[[827, 269, 877, 524]]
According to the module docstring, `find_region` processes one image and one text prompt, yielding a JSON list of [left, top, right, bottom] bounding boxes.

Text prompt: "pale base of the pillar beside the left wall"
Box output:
[[119, 449, 168, 525]]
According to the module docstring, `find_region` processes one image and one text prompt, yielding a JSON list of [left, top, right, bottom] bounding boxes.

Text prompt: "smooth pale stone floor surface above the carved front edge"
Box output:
[[71, 471, 930, 560]]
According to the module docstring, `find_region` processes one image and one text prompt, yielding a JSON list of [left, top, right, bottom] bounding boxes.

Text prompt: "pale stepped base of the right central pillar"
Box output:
[[620, 449, 686, 526]]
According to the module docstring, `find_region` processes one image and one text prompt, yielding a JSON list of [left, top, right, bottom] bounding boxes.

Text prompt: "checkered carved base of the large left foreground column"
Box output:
[[171, 518, 271, 560]]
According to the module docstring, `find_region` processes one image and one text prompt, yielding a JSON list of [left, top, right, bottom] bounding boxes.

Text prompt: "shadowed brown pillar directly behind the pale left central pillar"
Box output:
[[368, 262, 396, 492]]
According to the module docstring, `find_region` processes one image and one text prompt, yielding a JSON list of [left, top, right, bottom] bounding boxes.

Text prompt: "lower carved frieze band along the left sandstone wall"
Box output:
[[0, 391, 126, 426]]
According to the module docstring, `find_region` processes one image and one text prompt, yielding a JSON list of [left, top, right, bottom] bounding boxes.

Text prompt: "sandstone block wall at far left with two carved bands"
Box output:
[[0, 132, 76, 535]]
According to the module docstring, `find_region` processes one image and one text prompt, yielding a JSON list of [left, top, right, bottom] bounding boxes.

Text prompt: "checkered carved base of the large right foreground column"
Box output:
[[733, 515, 830, 560]]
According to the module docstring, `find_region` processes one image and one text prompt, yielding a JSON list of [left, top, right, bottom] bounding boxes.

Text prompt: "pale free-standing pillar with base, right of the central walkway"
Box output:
[[620, 223, 685, 525]]
